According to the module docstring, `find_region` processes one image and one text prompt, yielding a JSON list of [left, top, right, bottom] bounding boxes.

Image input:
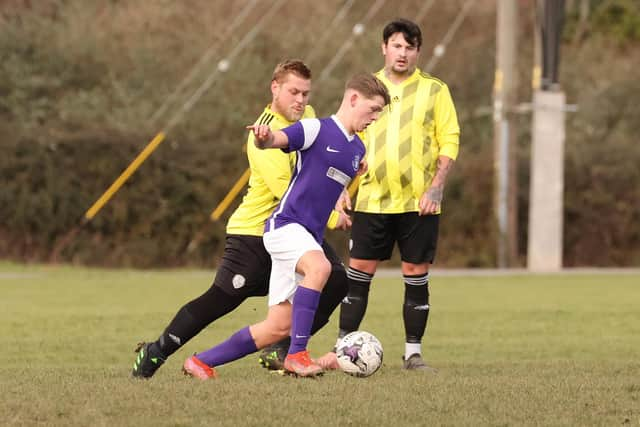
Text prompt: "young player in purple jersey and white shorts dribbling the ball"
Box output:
[[183, 74, 390, 380]]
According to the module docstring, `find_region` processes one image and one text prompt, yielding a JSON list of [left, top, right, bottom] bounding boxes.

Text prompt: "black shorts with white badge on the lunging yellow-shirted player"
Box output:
[[213, 234, 344, 297]]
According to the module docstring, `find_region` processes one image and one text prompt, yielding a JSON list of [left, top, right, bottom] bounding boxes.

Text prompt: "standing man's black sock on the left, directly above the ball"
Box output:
[[339, 267, 373, 338]]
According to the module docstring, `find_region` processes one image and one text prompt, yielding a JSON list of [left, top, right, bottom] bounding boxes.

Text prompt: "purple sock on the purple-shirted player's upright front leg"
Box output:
[[289, 286, 320, 354]]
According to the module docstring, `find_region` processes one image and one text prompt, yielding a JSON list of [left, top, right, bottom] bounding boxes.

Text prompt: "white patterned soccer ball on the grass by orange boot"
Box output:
[[336, 331, 382, 377]]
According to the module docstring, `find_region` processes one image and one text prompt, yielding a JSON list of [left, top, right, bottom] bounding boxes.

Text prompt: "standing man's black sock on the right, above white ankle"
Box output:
[[402, 273, 429, 343]]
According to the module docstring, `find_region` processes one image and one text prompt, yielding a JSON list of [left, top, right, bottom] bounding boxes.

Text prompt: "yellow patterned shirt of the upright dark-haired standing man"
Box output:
[[355, 69, 460, 213]]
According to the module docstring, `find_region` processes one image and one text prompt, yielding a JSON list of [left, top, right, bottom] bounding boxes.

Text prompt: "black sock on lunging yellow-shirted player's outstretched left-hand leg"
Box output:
[[156, 285, 245, 357]]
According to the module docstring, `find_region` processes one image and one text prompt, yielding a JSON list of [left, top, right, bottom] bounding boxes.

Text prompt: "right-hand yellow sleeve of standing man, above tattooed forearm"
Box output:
[[434, 85, 460, 160]]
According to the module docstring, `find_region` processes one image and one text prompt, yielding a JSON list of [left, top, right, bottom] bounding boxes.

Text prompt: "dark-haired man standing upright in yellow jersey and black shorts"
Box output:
[[320, 19, 460, 369]]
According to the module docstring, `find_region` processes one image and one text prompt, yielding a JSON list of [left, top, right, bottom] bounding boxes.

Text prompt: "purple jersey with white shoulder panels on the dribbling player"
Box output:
[[265, 116, 365, 244]]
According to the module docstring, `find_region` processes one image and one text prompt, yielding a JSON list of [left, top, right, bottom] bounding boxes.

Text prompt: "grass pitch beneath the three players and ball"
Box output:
[[0, 264, 640, 427]]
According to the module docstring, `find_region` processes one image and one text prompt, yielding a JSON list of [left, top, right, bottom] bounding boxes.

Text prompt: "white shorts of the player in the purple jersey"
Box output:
[[262, 224, 322, 307]]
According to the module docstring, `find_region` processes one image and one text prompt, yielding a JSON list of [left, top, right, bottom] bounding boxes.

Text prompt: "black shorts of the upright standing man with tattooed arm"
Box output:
[[349, 212, 440, 264]]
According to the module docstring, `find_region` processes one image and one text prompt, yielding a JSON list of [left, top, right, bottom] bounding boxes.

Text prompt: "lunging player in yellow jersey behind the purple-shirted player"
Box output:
[[132, 60, 348, 378]]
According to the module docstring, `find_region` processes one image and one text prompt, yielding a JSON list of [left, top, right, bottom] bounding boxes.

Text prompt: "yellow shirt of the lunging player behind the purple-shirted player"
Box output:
[[227, 105, 316, 236]]
